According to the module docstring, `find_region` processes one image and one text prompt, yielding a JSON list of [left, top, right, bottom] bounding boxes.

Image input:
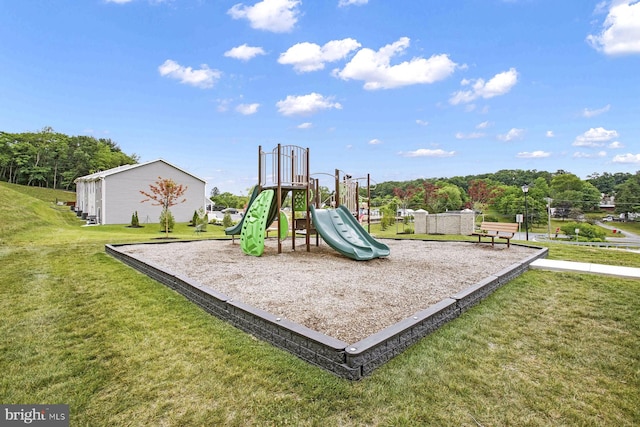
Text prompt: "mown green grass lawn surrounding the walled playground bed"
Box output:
[[0, 183, 640, 426]]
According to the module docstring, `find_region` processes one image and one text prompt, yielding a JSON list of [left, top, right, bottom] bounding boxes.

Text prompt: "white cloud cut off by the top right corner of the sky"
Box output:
[[587, 0, 640, 55]]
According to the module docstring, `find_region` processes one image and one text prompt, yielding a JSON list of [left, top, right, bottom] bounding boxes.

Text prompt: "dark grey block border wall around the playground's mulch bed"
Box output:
[[105, 242, 549, 380]]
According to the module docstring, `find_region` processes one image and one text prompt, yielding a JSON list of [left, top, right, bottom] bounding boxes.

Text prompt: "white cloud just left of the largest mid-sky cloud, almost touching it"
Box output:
[[278, 39, 360, 73]]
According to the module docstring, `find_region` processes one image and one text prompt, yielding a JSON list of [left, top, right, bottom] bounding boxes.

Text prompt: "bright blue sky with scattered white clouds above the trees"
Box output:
[[0, 0, 640, 194]]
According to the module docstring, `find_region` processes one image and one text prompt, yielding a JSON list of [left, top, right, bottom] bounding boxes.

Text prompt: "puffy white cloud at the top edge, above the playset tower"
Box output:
[[227, 0, 301, 33]]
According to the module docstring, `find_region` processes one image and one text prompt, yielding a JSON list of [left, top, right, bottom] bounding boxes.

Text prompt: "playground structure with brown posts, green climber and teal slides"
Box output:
[[225, 144, 389, 261]]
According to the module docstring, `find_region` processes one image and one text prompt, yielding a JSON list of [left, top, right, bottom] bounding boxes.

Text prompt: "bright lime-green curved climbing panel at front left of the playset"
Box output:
[[240, 190, 274, 256]]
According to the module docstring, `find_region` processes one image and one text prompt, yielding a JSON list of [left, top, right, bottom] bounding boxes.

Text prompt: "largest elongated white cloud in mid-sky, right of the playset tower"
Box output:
[[333, 37, 457, 90]]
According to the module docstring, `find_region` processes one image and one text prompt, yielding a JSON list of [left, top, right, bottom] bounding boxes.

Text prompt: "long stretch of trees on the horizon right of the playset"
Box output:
[[368, 170, 640, 226]]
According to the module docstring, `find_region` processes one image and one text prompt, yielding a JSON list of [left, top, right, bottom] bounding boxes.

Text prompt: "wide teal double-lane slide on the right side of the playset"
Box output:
[[310, 206, 390, 261]]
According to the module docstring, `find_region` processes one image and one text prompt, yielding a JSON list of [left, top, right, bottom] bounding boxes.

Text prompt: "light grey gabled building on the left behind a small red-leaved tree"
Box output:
[[75, 159, 206, 224]]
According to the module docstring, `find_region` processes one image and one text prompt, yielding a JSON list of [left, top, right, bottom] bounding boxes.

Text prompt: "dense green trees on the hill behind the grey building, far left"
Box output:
[[0, 127, 139, 190]]
